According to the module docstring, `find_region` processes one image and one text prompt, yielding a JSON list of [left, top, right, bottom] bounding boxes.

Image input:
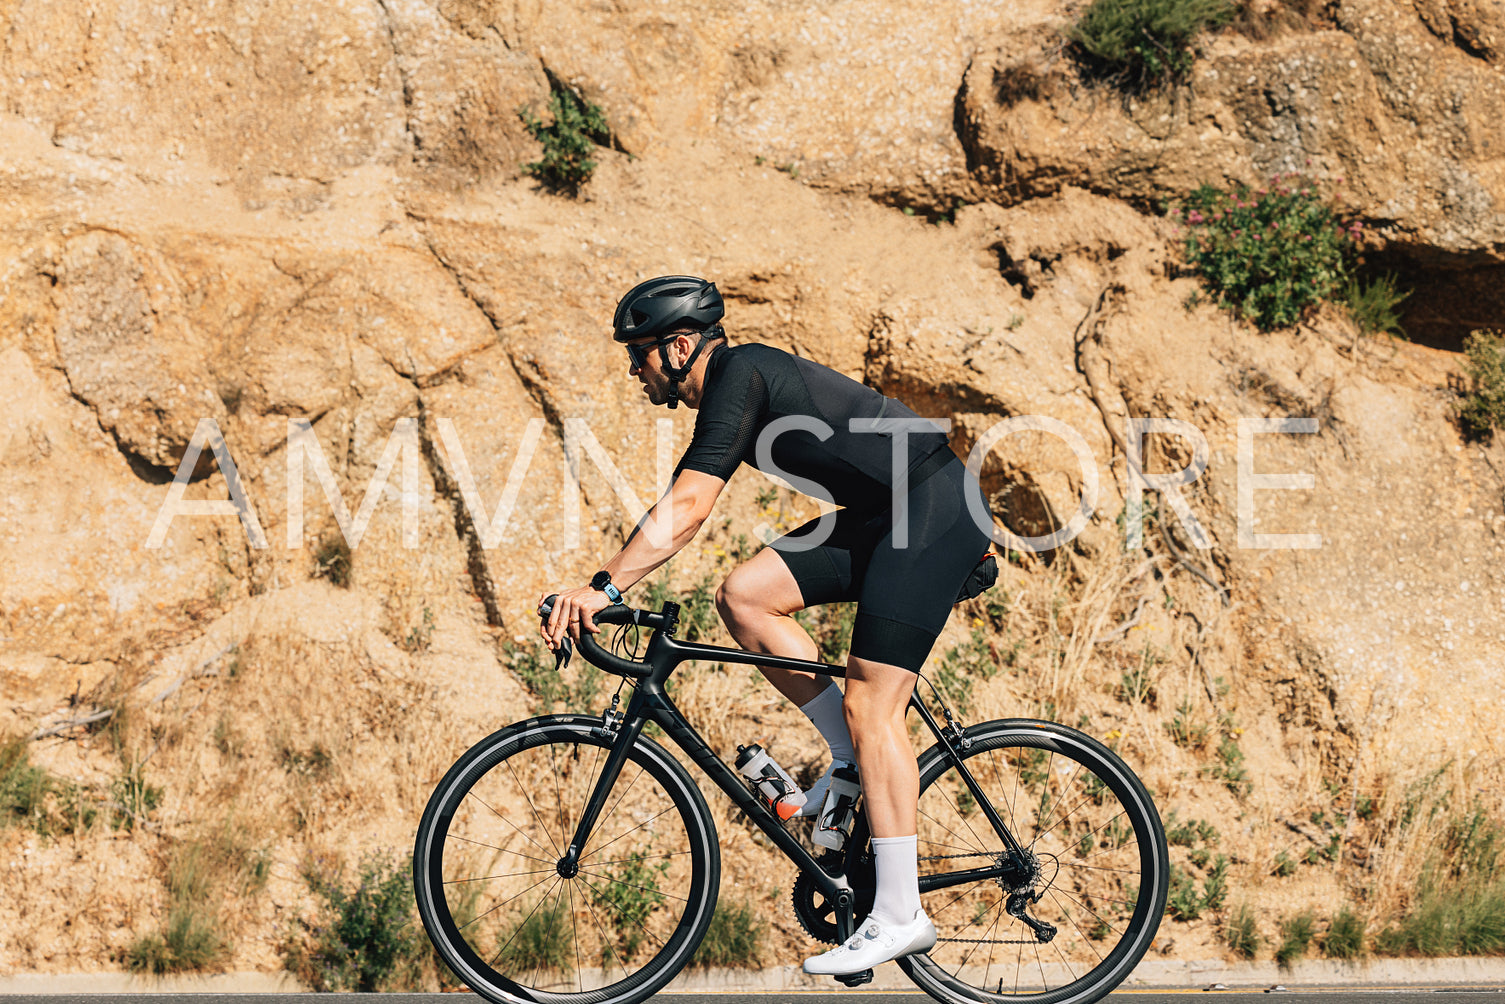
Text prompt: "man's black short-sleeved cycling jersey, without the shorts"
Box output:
[[674, 343, 947, 509]]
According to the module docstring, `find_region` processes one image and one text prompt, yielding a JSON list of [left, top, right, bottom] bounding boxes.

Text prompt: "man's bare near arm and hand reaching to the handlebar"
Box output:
[[539, 471, 727, 649]]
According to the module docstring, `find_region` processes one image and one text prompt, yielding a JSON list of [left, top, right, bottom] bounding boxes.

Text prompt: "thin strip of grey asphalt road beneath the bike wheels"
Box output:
[[0, 986, 1505, 1004]]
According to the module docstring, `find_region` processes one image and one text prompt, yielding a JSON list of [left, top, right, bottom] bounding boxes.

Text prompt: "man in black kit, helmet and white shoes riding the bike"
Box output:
[[540, 275, 989, 975]]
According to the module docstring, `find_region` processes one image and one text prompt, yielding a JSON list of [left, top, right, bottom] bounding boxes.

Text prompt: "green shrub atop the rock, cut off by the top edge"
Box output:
[[1067, 0, 1237, 89]]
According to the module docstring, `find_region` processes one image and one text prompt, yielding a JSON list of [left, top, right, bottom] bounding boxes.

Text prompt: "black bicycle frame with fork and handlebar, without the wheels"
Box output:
[[558, 604, 1026, 939]]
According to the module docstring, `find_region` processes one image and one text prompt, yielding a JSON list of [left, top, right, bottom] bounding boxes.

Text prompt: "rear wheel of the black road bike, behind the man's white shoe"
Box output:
[[898, 720, 1169, 1004]]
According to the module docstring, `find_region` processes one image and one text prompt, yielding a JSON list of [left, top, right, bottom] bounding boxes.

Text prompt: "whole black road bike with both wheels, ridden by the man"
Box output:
[[412, 602, 1169, 1004]]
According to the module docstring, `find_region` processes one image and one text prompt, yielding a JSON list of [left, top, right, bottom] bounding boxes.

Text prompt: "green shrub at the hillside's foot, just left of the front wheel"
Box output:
[[287, 855, 424, 993]]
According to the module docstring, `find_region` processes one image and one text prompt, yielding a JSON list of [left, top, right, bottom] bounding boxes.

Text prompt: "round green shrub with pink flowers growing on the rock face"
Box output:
[[1177, 175, 1359, 331]]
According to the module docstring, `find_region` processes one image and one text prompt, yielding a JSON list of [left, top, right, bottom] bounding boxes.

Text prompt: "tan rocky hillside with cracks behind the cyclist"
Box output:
[[0, 0, 1505, 972]]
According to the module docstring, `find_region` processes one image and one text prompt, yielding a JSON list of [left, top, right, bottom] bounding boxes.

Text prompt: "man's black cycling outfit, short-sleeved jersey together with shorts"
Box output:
[[674, 345, 989, 671]]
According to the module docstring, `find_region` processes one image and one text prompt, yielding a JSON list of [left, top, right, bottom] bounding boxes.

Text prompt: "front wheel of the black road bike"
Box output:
[[412, 715, 721, 1004]]
